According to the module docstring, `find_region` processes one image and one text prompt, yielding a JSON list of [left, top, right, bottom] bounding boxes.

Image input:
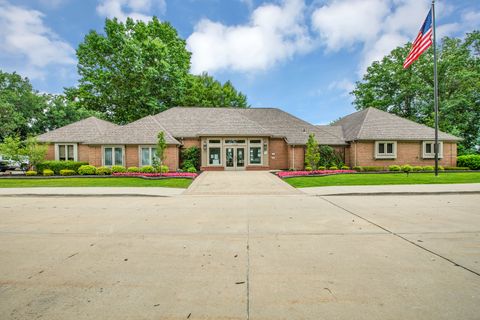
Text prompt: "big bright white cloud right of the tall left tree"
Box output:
[[187, 0, 311, 73]]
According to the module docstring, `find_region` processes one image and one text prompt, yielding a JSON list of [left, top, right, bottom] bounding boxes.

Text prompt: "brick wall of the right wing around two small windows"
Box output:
[[350, 141, 457, 167]]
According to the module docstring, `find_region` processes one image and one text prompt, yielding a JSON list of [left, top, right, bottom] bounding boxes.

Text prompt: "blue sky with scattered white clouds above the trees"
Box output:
[[0, 0, 480, 124]]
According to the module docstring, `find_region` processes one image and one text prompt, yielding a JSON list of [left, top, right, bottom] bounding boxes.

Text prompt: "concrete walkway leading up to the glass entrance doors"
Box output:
[[184, 171, 301, 195]]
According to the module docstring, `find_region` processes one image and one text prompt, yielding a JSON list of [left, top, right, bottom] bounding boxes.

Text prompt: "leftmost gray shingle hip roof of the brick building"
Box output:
[[37, 117, 118, 143]]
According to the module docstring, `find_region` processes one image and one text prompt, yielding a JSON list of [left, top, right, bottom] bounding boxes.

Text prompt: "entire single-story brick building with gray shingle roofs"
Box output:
[[38, 107, 460, 170]]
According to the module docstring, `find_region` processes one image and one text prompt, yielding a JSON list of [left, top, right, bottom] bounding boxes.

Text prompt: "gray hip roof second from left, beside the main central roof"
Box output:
[[85, 116, 180, 144]]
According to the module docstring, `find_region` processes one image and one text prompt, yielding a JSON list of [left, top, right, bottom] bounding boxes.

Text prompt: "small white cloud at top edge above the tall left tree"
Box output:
[[97, 0, 167, 21]]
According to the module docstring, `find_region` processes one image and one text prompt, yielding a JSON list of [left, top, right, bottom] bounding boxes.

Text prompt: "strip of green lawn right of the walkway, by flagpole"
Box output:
[[284, 172, 480, 188]]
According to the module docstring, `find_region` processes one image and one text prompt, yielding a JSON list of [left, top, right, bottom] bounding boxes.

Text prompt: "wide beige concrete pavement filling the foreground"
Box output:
[[0, 194, 480, 320]]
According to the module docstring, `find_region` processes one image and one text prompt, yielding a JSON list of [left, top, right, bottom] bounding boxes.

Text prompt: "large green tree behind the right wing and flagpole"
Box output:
[[352, 31, 480, 153]]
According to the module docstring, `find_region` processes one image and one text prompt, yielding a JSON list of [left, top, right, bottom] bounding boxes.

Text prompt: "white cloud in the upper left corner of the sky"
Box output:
[[0, 0, 76, 79]]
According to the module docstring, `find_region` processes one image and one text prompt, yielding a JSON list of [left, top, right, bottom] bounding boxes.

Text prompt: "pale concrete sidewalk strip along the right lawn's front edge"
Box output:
[[298, 183, 480, 196]]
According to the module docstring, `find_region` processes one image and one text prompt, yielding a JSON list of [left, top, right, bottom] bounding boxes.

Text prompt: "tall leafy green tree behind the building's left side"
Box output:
[[66, 17, 247, 124]]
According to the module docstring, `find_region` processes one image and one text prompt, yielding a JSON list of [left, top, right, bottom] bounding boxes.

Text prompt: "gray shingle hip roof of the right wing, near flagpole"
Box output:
[[334, 108, 462, 141]]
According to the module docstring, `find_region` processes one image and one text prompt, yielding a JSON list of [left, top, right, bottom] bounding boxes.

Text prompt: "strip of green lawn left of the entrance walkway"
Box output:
[[0, 178, 193, 188]]
